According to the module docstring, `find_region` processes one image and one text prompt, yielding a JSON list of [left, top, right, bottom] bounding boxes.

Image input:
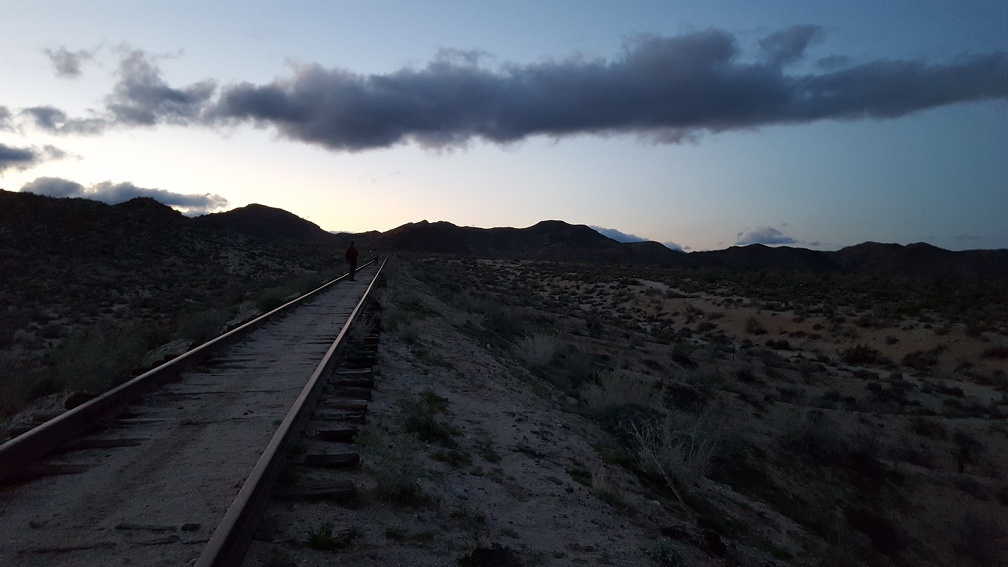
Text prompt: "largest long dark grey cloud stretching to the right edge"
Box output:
[[206, 26, 1008, 151]]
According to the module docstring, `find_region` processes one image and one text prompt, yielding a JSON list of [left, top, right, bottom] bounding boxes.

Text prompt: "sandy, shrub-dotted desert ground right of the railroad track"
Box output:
[[249, 258, 1008, 566]]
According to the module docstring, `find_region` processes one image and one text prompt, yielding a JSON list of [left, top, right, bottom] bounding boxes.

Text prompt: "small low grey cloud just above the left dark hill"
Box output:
[[21, 178, 228, 216]]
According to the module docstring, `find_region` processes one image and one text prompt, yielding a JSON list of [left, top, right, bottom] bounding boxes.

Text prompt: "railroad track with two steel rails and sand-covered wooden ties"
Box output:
[[0, 263, 381, 567]]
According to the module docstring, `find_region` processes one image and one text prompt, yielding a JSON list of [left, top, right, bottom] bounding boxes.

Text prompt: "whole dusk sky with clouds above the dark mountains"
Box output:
[[0, 0, 1008, 251]]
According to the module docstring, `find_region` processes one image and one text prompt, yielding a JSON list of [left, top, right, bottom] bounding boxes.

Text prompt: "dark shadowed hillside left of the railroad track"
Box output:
[[0, 190, 342, 328]]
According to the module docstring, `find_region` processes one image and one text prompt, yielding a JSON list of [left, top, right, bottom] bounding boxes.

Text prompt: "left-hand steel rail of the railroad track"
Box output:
[[0, 259, 376, 483]]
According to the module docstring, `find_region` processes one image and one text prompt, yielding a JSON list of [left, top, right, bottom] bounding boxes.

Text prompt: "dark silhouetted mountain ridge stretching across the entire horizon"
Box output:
[[0, 190, 1008, 277]]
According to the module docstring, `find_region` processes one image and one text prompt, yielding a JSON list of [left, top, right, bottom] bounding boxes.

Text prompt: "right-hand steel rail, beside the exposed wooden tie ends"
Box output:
[[195, 255, 385, 567]]
